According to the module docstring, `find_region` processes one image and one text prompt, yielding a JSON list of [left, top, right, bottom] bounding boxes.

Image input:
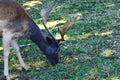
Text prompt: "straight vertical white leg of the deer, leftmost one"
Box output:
[[3, 30, 13, 80]]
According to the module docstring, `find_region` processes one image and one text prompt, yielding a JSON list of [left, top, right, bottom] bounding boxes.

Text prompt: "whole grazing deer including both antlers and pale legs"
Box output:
[[0, 0, 79, 80]]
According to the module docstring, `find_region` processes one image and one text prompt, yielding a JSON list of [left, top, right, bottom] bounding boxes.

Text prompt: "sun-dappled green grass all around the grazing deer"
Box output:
[[0, 0, 120, 80]]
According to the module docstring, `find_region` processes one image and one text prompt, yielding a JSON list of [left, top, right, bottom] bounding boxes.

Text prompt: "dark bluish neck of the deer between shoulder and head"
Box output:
[[28, 20, 47, 51]]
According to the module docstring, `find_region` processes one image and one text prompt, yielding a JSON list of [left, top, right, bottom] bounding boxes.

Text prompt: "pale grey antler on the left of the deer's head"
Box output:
[[40, 6, 54, 38]]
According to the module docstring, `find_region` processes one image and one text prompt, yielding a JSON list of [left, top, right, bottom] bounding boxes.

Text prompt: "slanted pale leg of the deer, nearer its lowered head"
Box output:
[[11, 39, 29, 70]]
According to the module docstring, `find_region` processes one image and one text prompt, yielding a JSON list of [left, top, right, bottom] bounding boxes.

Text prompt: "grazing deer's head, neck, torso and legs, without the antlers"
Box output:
[[0, 0, 59, 80]]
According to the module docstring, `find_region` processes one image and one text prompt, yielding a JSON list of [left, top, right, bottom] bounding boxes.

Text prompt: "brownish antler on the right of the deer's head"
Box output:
[[58, 14, 79, 41]]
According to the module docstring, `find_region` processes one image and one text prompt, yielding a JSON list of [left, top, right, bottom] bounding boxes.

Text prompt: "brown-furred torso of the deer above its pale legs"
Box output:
[[0, 0, 30, 33]]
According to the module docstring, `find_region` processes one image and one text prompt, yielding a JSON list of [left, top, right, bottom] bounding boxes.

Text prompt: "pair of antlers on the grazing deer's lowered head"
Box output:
[[40, 6, 79, 42]]
